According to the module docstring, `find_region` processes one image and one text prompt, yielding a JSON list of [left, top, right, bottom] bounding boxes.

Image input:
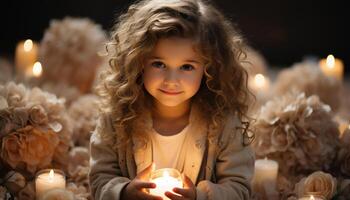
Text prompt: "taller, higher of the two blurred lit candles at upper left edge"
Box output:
[[15, 39, 38, 76]]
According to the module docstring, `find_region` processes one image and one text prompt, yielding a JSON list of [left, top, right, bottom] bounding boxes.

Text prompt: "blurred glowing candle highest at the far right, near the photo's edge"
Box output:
[[319, 55, 344, 80]]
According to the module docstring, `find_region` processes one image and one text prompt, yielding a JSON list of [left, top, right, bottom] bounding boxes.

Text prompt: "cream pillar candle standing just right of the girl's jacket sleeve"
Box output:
[[253, 158, 278, 194]]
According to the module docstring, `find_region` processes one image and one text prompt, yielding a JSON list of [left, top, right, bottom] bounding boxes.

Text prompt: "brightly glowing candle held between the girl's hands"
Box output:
[[150, 168, 183, 200]]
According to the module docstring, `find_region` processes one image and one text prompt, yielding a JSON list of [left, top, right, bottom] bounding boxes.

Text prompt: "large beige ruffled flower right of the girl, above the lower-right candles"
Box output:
[[253, 93, 340, 177]]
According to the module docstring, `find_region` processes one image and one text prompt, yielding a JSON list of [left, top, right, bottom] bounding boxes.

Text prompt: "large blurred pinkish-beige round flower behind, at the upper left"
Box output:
[[39, 17, 107, 93]]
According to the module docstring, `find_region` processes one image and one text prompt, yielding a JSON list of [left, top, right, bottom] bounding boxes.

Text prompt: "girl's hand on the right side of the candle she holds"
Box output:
[[165, 175, 196, 200]]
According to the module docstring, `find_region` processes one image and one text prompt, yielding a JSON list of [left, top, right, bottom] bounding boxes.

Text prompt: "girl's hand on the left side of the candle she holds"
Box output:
[[121, 163, 162, 200]]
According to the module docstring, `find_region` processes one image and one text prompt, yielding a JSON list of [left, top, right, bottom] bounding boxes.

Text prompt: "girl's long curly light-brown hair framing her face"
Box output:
[[97, 0, 250, 147]]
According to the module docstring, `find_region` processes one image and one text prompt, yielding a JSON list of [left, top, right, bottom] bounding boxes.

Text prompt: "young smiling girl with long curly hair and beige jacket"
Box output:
[[89, 0, 254, 200]]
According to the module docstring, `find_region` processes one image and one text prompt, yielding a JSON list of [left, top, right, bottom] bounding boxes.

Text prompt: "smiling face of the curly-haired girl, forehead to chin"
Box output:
[[143, 37, 204, 107]]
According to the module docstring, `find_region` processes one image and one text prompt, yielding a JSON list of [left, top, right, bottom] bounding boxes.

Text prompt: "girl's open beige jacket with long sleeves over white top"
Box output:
[[89, 106, 255, 200]]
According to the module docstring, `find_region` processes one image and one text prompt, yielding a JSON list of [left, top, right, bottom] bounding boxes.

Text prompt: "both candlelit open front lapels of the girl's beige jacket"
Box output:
[[132, 104, 207, 183]]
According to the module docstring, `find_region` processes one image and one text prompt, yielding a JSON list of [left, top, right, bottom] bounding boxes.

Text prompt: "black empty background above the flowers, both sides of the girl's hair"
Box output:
[[0, 0, 350, 74]]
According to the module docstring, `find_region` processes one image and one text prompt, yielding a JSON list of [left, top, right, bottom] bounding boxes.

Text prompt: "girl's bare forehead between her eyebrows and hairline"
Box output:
[[151, 37, 201, 59]]
